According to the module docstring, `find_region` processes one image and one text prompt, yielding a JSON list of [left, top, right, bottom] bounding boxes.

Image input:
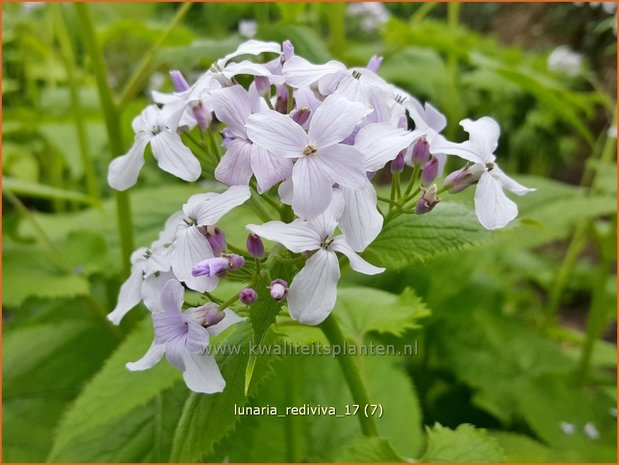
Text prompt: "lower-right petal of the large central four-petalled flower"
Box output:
[[318, 144, 368, 192]]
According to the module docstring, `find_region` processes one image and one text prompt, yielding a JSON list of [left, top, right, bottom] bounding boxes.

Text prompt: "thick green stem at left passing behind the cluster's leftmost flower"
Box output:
[[75, 3, 133, 274]]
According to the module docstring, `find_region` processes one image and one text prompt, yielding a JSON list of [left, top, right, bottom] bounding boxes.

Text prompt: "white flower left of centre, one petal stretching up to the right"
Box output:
[[170, 186, 251, 292]]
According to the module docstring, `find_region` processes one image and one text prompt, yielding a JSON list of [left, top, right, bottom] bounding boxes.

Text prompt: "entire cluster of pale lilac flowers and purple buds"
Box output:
[[108, 40, 532, 392]]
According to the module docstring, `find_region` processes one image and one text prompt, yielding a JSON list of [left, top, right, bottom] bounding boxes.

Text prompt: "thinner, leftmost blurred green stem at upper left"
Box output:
[[52, 5, 101, 204]]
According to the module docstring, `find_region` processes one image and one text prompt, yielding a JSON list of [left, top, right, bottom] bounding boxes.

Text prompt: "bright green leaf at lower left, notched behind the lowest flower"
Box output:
[[49, 319, 180, 462]]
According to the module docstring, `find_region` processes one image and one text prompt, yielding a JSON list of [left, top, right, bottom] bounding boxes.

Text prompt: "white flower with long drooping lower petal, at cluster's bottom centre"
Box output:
[[247, 195, 385, 325]]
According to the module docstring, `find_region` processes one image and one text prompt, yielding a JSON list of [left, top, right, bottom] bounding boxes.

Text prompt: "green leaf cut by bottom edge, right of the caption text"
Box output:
[[421, 424, 505, 463]]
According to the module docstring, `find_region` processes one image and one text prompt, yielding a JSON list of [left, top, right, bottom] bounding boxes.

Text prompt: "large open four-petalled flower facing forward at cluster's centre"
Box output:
[[247, 95, 369, 219]]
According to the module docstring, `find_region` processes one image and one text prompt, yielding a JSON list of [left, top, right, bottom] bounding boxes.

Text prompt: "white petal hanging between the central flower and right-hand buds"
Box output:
[[340, 181, 383, 252]]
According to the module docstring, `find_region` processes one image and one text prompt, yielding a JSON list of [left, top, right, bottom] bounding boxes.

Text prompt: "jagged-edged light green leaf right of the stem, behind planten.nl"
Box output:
[[334, 287, 430, 344]]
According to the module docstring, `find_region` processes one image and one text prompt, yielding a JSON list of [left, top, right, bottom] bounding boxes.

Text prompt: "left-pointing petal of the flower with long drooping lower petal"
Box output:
[[247, 220, 322, 253]]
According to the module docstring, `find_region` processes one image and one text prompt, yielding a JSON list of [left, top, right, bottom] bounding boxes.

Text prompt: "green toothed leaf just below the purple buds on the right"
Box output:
[[364, 202, 491, 269]]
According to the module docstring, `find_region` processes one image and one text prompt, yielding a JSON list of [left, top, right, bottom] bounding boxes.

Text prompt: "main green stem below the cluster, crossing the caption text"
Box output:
[[320, 314, 378, 436]]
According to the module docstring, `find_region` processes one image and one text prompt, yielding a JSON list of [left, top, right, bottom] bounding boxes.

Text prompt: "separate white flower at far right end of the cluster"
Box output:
[[444, 116, 535, 229]]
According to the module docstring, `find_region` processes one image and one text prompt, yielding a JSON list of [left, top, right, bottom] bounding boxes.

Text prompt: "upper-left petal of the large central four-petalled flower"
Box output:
[[246, 110, 309, 158]]
